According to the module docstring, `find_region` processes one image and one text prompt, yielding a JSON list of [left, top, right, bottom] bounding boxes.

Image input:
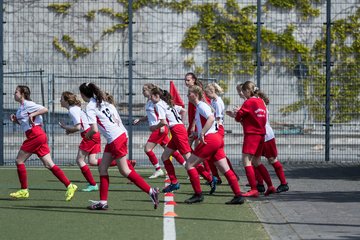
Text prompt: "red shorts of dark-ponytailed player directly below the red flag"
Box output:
[[167, 124, 191, 155]]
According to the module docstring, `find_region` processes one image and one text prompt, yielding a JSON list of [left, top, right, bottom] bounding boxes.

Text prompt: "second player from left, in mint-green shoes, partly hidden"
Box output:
[[59, 91, 101, 192]]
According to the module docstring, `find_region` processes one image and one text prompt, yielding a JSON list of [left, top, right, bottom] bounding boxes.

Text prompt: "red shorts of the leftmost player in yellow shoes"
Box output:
[[20, 126, 50, 157]]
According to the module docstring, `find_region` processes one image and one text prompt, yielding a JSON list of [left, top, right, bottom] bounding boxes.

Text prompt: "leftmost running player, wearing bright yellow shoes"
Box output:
[[10, 85, 77, 201]]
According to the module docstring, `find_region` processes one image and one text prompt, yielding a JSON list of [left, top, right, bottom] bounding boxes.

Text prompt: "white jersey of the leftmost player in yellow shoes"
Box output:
[[16, 100, 44, 132]]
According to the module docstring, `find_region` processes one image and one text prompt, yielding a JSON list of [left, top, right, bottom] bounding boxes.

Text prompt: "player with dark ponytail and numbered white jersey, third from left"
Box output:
[[79, 83, 159, 210]]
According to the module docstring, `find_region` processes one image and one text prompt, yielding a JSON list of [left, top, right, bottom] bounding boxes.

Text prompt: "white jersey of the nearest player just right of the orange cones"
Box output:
[[195, 101, 217, 137]]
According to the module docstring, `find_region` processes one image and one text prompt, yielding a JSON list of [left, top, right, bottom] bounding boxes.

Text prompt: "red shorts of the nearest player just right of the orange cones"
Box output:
[[193, 133, 226, 161]]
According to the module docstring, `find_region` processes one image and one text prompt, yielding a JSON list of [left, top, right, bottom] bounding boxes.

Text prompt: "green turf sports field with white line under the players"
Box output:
[[0, 168, 269, 240]]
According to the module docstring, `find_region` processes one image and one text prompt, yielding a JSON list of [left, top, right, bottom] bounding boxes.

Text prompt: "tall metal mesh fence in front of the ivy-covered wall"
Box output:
[[3, 0, 360, 165]]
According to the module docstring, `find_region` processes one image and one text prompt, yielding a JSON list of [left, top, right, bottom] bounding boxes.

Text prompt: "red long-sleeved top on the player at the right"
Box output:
[[235, 97, 266, 135]]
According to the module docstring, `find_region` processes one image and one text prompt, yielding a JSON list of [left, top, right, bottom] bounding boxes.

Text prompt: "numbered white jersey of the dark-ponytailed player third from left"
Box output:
[[86, 98, 127, 143]]
